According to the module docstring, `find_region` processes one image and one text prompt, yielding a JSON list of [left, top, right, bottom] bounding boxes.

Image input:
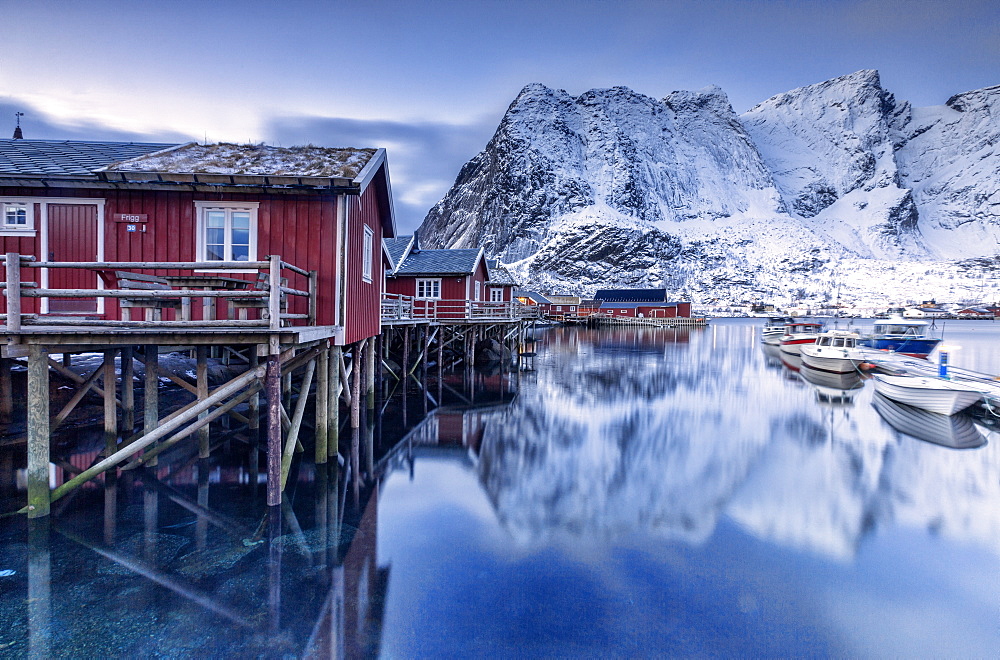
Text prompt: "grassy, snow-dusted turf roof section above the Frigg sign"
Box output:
[[103, 142, 376, 179]]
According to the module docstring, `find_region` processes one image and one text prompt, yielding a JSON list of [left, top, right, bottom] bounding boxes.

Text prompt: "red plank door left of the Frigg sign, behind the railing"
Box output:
[[48, 204, 97, 314]]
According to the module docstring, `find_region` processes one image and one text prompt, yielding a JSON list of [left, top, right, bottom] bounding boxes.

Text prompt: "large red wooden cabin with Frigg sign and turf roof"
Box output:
[[0, 140, 395, 344]]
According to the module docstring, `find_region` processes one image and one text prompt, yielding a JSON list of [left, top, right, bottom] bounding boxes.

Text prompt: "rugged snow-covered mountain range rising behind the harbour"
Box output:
[[420, 70, 1000, 305]]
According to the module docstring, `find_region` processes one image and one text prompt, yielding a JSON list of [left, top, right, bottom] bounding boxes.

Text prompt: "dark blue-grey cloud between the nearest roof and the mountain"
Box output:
[[264, 116, 500, 233]]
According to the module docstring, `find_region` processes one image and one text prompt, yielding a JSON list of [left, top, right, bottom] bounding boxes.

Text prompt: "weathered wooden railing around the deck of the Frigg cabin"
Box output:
[[0, 252, 317, 334]]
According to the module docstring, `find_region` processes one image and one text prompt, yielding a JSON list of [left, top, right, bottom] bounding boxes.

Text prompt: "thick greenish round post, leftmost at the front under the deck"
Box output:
[[26, 342, 51, 518]]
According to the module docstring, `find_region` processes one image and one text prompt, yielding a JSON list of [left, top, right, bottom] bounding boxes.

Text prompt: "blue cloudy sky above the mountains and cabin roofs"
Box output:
[[0, 0, 1000, 233]]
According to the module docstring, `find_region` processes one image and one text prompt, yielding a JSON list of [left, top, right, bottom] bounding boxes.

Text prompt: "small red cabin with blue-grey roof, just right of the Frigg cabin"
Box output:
[[386, 234, 488, 319]]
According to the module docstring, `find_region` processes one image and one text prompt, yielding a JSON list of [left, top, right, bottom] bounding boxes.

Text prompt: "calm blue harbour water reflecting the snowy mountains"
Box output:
[[0, 320, 1000, 658]]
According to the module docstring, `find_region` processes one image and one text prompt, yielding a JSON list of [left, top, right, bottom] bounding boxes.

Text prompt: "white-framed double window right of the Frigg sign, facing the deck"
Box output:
[[195, 202, 258, 261]]
